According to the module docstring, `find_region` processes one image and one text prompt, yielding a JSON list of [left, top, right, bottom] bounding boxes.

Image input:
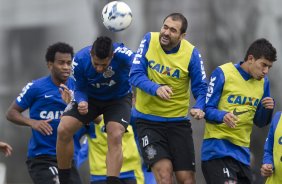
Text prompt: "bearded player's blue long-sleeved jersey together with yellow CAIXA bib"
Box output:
[[130, 32, 207, 122]]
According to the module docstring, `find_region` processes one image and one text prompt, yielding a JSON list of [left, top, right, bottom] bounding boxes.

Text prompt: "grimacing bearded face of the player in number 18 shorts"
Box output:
[[159, 17, 185, 50]]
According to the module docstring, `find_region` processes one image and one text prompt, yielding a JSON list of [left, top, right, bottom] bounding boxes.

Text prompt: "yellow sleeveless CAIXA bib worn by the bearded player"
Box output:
[[136, 33, 194, 118]]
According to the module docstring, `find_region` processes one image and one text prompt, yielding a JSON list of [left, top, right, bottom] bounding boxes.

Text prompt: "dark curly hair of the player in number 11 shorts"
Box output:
[[45, 42, 74, 62]]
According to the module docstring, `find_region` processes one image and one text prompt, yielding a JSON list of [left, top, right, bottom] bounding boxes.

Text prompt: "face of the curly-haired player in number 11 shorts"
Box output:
[[48, 52, 72, 85]]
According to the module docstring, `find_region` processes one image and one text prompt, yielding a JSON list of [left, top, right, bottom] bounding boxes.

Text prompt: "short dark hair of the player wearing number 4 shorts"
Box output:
[[244, 38, 277, 62]]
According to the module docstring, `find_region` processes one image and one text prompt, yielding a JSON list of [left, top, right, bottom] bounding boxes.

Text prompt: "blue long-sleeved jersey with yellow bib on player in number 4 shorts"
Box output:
[[202, 62, 273, 165]]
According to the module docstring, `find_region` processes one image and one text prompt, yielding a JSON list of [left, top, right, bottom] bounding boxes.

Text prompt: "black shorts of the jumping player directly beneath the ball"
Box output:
[[63, 93, 132, 129]]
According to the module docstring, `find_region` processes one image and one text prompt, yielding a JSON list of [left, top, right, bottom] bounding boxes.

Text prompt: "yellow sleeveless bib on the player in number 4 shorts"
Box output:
[[204, 63, 264, 147]]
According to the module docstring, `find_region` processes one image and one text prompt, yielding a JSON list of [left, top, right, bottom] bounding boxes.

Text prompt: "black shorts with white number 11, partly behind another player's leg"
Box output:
[[26, 156, 82, 184]]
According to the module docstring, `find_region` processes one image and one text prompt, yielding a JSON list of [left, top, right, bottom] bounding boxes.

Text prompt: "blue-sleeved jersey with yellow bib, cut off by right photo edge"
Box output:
[[263, 111, 282, 184]]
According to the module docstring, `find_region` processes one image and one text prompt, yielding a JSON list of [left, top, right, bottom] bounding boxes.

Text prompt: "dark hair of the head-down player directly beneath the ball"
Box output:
[[91, 36, 113, 59]]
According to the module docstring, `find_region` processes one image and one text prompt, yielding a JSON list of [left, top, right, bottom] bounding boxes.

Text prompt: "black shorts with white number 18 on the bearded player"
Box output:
[[136, 119, 195, 171]]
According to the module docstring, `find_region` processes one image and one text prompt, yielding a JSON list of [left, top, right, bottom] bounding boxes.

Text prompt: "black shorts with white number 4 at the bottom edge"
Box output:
[[202, 157, 252, 184]]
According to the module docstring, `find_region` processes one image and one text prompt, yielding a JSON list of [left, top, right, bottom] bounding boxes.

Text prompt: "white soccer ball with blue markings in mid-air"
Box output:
[[102, 1, 132, 32]]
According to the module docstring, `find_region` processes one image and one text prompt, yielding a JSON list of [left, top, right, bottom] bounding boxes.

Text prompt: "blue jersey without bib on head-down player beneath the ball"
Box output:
[[72, 43, 134, 103]]
